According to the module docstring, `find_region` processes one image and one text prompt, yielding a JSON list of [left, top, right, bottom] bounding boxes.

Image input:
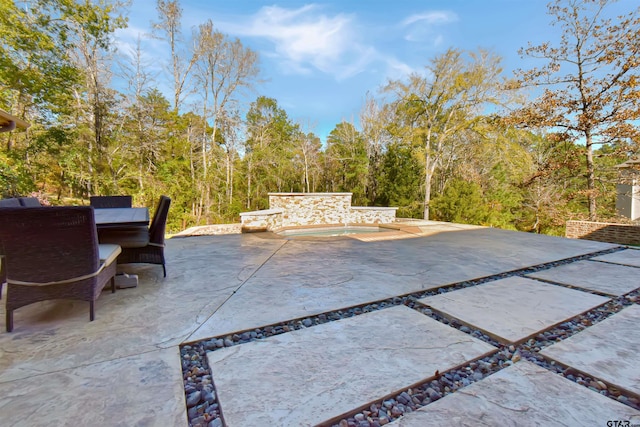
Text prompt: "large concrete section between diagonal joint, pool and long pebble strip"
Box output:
[[188, 228, 615, 341]]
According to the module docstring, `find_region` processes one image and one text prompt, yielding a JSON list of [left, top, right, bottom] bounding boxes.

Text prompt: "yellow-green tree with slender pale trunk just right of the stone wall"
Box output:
[[384, 49, 510, 219]]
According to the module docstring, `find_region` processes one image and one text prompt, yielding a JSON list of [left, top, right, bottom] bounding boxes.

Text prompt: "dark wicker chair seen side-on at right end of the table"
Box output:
[[118, 196, 171, 277]]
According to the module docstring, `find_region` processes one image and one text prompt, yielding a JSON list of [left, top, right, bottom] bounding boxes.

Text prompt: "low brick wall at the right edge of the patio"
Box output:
[[565, 221, 640, 245]]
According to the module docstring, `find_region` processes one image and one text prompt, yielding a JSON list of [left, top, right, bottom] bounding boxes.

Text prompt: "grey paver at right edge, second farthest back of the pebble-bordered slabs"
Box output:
[[527, 261, 640, 296]]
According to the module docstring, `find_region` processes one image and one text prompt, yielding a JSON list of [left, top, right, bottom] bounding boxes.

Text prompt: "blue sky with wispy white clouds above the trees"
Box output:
[[116, 0, 636, 144]]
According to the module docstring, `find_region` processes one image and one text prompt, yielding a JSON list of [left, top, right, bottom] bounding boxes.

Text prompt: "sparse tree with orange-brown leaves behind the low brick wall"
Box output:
[[514, 0, 640, 221]]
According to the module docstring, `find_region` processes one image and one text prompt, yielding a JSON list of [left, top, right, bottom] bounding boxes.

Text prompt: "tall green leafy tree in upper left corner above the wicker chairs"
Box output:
[[0, 0, 125, 201]]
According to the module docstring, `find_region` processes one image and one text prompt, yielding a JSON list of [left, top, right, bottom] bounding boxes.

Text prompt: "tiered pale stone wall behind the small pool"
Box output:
[[240, 193, 397, 231]]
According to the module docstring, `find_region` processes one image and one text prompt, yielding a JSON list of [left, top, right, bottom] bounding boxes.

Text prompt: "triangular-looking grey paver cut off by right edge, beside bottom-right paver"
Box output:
[[541, 305, 640, 395]]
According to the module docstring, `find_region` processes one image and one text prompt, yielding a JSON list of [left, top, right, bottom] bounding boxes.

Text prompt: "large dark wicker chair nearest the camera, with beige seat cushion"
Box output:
[[0, 206, 120, 332]]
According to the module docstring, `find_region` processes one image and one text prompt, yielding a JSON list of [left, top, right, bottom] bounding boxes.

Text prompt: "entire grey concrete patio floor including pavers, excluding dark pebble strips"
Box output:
[[0, 221, 640, 427]]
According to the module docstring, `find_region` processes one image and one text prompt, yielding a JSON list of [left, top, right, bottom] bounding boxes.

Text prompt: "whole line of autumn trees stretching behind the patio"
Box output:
[[0, 0, 640, 234]]
